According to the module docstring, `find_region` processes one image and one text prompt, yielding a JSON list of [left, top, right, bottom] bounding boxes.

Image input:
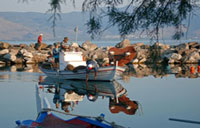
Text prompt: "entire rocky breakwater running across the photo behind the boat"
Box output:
[[0, 39, 200, 65]]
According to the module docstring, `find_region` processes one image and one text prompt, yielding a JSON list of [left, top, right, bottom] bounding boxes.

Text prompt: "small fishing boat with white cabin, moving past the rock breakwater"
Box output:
[[40, 52, 125, 81]]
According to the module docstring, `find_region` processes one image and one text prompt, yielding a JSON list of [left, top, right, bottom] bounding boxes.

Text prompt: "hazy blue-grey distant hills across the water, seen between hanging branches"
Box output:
[[0, 12, 200, 41]]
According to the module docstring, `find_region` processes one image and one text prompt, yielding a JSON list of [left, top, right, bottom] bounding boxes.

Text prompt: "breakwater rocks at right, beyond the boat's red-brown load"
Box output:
[[133, 42, 200, 64]]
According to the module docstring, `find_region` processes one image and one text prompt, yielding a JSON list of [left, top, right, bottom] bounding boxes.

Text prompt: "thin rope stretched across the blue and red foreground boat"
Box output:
[[39, 108, 124, 128]]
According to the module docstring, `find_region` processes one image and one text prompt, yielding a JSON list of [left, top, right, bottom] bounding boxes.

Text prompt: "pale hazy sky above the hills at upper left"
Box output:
[[0, 0, 83, 13]]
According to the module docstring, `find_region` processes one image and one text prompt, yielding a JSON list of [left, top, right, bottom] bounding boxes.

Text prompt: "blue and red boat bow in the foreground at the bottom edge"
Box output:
[[16, 85, 122, 128]]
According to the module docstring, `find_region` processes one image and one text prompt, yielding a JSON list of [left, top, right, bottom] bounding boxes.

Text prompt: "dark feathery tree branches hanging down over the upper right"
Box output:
[[19, 0, 200, 40]]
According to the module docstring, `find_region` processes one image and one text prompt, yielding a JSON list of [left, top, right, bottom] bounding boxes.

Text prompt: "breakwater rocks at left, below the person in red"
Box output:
[[0, 42, 52, 64]]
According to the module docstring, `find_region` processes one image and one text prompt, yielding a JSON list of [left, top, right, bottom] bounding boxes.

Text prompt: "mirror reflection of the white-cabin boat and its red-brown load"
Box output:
[[39, 77, 138, 115]]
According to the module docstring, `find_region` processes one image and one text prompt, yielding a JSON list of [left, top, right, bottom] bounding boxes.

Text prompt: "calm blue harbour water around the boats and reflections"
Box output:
[[0, 65, 200, 128]]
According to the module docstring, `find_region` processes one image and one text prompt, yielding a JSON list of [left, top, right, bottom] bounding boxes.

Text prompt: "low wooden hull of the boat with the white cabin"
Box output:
[[41, 66, 125, 81]]
